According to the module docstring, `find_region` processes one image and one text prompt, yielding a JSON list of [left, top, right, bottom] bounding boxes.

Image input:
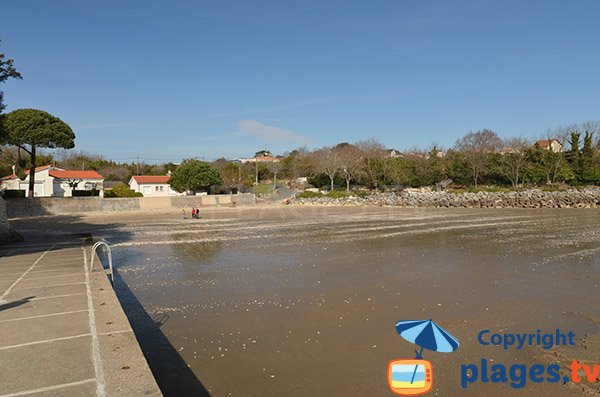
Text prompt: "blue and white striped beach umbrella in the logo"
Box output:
[[396, 320, 460, 359]]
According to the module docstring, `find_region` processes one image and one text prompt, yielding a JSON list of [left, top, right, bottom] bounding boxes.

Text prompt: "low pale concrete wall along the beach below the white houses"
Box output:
[[5, 193, 256, 218]]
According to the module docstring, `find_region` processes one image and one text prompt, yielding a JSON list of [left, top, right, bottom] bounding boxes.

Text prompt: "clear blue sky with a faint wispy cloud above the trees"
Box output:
[[0, 0, 600, 160]]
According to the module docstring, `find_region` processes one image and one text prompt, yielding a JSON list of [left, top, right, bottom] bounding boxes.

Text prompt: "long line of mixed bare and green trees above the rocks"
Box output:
[[214, 122, 600, 191]]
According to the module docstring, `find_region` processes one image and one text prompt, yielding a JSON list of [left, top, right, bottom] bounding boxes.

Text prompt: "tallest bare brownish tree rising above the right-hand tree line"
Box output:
[[455, 128, 502, 187]]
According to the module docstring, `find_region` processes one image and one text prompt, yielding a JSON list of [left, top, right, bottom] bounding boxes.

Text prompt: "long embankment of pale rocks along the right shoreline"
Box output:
[[290, 189, 600, 208]]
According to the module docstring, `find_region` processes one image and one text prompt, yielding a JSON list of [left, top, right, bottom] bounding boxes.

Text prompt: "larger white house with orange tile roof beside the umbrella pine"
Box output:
[[0, 165, 104, 197]]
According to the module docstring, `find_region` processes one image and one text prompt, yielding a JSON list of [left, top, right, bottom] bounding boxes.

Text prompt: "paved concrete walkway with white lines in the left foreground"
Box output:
[[0, 240, 161, 397]]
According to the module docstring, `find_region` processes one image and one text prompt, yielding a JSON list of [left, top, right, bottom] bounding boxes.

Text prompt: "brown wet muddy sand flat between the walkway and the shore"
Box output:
[[13, 206, 600, 396]]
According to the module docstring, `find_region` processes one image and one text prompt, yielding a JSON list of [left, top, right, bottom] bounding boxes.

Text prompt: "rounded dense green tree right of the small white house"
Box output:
[[169, 160, 223, 193]]
